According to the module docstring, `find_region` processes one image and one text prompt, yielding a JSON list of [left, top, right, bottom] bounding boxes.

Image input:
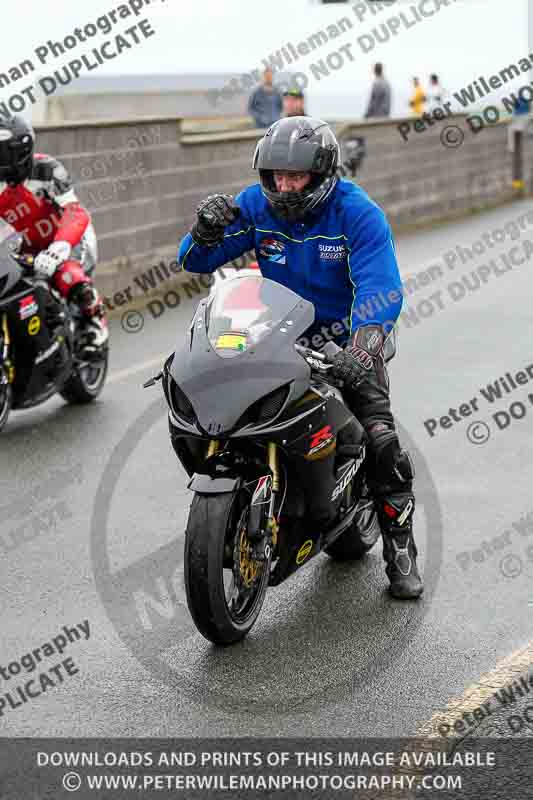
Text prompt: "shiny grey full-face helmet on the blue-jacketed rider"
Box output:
[[252, 117, 340, 222]]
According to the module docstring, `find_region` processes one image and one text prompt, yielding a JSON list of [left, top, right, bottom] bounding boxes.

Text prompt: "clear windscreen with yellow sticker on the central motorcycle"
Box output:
[[206, 275, 300, 358]]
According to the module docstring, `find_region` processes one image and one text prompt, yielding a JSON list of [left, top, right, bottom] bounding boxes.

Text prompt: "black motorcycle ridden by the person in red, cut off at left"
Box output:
[[0, 220, 108, 431]]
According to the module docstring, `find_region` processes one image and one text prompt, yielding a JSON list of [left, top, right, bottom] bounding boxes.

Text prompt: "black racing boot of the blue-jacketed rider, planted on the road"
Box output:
[[376, 492, 424, 600]]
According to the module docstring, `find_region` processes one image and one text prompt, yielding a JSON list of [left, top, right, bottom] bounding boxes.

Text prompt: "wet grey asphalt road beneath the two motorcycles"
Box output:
[[0, 201, 533, 736]]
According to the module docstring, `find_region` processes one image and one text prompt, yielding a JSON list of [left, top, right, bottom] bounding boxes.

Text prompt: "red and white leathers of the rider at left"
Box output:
[[0, 154, 107, 343]]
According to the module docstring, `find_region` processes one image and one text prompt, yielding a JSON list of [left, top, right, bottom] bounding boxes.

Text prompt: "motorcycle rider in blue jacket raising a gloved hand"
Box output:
[[178, 117, 423, 599]]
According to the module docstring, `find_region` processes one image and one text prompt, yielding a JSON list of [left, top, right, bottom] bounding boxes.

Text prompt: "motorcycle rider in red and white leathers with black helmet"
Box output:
[[0, 115, 109, 352]]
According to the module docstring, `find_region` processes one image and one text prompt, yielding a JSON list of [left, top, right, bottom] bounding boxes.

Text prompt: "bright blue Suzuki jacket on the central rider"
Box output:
[[178, 180, 403, 346]]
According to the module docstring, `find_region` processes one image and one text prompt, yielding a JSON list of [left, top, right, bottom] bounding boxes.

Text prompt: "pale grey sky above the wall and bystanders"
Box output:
[[0, 0, 528, 115]]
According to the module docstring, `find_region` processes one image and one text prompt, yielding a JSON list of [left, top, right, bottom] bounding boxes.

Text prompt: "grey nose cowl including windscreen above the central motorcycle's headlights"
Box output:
[[170, 275, 315, 435]]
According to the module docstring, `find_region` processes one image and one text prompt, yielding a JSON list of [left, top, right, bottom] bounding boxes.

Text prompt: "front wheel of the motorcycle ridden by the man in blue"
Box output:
[[184, 489, 271, 645]]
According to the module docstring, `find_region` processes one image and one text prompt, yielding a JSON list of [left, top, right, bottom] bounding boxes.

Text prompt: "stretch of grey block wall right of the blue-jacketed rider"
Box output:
[[339, 116, 520, 229]]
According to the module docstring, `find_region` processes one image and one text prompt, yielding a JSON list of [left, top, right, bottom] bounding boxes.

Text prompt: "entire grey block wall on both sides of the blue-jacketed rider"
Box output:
[[33, 117, 531, 306]]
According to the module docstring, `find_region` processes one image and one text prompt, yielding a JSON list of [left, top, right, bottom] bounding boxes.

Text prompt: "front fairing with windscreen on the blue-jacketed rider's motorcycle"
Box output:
[[163, 276, 361, 519]]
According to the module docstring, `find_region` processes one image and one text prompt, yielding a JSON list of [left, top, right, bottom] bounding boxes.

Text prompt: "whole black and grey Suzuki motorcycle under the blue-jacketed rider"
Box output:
[[145, 275, 392, 644]]
